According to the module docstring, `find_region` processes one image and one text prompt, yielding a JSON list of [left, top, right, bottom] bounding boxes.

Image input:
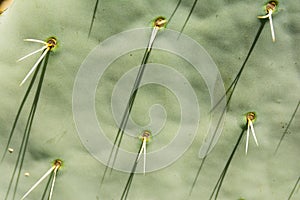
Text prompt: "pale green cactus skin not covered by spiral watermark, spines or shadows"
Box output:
[[0, 0, 300, 200]]
